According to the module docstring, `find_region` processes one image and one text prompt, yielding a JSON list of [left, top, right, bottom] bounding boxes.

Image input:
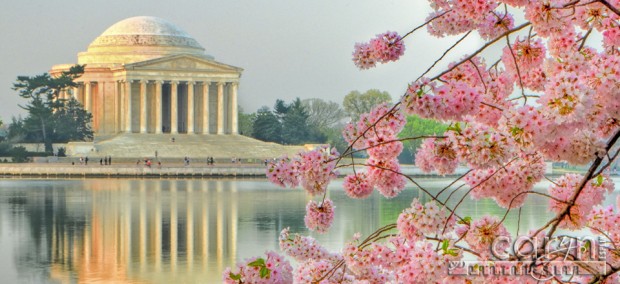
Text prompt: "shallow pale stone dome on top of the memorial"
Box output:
[[78, 16, 210, 65]]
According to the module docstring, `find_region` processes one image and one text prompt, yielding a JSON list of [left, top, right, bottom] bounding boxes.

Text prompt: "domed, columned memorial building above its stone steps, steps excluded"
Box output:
[[50, 16, 243, 135]]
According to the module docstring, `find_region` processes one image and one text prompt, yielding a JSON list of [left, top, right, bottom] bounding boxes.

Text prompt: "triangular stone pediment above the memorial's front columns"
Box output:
[[124, 54, 243, 73]]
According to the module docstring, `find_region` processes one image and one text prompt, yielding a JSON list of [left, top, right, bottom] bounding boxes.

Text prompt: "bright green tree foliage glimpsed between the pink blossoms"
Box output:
[[398, 115, 448, 163]]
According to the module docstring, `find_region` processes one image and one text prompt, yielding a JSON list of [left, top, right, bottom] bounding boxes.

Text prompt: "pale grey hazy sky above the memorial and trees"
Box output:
[[0, 0, 478, 122]]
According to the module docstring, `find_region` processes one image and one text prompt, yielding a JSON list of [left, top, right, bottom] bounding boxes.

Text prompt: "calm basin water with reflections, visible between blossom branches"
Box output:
[[0, 178, 620, 283]]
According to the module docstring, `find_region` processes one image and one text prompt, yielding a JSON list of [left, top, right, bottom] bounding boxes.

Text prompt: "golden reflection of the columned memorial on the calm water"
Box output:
[[46, 180, 238, 283]]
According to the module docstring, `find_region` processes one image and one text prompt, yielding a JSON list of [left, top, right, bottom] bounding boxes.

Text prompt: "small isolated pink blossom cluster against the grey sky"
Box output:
[[353, 31, 405, 69]]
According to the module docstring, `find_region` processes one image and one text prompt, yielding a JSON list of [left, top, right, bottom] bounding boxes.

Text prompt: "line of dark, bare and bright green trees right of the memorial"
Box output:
[[239, 89, 447, 163]]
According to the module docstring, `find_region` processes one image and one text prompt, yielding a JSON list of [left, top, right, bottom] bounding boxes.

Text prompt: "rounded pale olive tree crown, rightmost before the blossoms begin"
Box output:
[[342, 89, 392, 120]]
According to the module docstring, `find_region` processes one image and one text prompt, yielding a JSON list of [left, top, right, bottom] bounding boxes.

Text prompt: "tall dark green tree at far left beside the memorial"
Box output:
[[13, 65, 92, 152]]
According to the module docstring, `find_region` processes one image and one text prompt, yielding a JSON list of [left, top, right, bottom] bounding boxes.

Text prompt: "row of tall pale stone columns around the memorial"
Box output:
[[68, 80, 238, 134]]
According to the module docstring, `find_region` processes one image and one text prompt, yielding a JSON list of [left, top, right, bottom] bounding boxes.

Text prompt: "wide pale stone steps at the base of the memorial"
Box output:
[[68, 134, 305, 160]]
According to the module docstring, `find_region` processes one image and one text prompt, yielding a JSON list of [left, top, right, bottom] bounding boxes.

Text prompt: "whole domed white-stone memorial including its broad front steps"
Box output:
[[50, 16, 303, 159]]
